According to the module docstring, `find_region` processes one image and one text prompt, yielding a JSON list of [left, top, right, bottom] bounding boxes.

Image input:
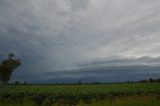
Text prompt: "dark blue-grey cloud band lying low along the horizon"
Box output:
[[13, 66, 160, 83]]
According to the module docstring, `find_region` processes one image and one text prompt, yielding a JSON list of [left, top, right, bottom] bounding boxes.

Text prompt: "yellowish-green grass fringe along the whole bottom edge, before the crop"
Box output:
[[0, 95, 160, 106]]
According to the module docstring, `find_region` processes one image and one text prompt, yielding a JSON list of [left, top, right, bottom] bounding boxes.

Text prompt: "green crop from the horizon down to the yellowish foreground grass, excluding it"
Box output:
[[0, 83, 160, 106]]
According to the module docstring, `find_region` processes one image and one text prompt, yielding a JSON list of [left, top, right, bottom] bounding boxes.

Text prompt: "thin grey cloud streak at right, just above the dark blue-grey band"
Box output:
[[77, 55, 160, 68]]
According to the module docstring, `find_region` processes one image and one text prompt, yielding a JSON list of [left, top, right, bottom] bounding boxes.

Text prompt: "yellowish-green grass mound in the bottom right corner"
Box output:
[[77, 95, 160, 106]]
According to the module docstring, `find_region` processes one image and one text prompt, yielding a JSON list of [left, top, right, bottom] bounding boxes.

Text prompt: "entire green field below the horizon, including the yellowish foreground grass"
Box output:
[[0, 83, 160, 106]]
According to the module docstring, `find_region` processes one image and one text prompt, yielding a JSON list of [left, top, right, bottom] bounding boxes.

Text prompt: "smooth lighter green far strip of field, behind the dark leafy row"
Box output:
[[0, 83, 160, 94]]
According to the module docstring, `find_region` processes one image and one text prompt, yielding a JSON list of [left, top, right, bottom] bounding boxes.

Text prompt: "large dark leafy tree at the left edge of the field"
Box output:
[[0, 53, 21, 84]]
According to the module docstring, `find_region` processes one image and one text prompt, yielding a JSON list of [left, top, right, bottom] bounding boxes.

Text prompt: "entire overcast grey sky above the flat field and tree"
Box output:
[[0, 0, 160, 83]]
